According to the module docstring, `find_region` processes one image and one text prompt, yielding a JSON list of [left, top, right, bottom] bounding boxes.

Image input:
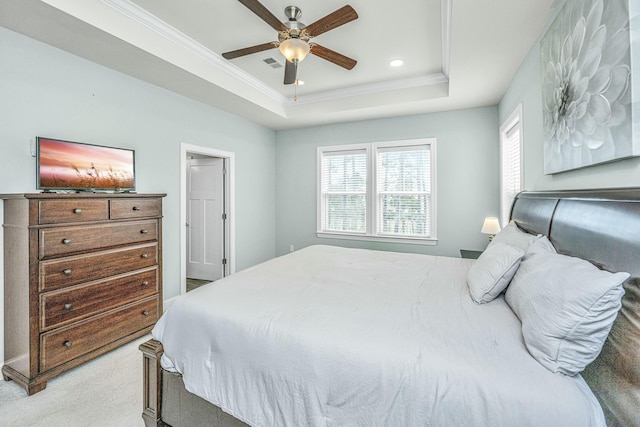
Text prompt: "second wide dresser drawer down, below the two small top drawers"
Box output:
[[39, 243, 158, 291]]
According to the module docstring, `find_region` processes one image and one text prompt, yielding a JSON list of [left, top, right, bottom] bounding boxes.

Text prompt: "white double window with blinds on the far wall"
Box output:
[[318, 139, 435, 243]]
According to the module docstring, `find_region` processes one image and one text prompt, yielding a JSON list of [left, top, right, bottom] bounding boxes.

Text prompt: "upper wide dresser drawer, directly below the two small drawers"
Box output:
[[40, 219, 158, 259]]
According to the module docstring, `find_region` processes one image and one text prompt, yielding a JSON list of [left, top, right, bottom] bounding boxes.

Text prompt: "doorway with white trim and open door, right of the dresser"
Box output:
[[180, 144, 235, 293]]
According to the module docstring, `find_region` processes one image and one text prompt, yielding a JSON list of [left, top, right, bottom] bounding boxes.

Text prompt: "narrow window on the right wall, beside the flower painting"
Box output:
[[500, 105, 522, 226]]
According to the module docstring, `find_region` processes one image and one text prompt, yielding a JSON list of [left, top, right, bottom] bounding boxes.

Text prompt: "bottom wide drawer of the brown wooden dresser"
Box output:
[[40, 297, 159, 371]]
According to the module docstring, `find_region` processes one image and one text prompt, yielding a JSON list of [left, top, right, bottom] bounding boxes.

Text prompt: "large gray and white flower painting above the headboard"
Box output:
[[540, 0, 637, 174]]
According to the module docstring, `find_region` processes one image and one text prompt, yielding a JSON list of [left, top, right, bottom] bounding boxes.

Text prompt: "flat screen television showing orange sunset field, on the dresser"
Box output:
[[36, 137, 136, 192]]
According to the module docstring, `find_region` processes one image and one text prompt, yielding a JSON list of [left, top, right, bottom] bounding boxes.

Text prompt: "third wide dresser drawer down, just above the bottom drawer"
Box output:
[[40, 267, 158, 330]]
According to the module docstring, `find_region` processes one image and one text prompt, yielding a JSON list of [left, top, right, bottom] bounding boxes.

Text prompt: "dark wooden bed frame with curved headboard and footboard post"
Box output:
[[140, 188, 640, 427]]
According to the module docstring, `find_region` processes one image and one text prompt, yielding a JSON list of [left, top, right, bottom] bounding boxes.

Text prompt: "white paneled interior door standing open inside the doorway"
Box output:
[[186, 157, 224, 280]]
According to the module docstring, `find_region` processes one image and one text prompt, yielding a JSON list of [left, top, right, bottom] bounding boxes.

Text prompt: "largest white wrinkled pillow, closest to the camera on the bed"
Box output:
[[505, 250, 629, 375]]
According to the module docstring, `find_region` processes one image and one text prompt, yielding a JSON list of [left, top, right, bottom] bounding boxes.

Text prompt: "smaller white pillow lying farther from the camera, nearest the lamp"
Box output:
[[467, 243, 524, 304]]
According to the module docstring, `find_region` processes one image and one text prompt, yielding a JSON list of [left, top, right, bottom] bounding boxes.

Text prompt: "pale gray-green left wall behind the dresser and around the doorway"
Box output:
[[0, 28, 275, 362]]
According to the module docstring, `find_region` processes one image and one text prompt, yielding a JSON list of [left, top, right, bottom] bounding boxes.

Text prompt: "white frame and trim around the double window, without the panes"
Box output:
[[316, 138, 438, 245]]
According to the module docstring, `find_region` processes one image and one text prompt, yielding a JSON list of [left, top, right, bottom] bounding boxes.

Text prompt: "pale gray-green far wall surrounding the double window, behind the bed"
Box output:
[[276, 107, 499, 256]]
